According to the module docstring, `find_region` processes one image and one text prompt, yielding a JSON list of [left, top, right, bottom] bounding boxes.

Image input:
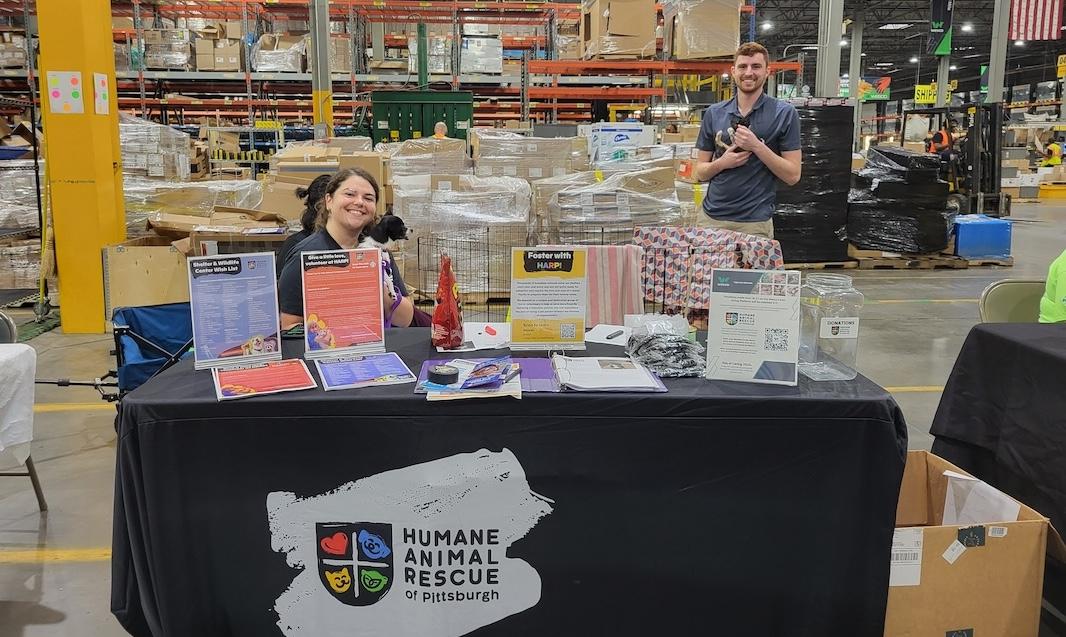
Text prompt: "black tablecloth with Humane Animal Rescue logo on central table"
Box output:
[[112, 329, 906, 637]]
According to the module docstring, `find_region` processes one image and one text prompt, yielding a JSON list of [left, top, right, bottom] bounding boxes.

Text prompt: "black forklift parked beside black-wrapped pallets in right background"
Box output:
[[903, 102, 1011, 217]]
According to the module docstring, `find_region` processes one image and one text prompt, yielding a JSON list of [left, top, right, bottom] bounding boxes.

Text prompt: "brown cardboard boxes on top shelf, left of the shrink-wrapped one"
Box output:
[[579, 0, 652, 60]]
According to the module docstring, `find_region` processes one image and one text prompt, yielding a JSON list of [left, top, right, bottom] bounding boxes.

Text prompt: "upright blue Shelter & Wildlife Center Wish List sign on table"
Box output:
[[188, 252, 281, 370]]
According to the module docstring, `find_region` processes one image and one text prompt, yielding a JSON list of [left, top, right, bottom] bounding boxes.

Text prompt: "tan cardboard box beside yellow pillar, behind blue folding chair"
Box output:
[[103, 237, 190, 317]]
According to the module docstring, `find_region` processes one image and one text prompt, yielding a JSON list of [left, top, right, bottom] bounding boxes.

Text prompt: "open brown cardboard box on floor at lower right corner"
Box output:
[[885, 451, 1066, 637]]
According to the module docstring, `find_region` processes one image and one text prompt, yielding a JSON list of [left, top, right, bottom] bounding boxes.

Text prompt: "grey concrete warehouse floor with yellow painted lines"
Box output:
[[0, 201, 1066, 637]]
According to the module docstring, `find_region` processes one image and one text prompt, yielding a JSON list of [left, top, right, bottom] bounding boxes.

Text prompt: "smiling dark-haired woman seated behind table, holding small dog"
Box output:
[[278, 168, 432, 329]]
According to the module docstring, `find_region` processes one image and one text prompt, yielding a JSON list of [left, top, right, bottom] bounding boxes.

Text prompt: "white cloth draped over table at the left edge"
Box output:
[[0, 343, 37, 464]]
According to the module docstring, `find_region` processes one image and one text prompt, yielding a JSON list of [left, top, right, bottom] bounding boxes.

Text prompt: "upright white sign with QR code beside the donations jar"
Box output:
[[707, 270, 800, 386]]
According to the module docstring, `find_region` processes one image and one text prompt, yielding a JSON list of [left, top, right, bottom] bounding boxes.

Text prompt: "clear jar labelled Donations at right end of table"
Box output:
[[800, 274, 863, 380]]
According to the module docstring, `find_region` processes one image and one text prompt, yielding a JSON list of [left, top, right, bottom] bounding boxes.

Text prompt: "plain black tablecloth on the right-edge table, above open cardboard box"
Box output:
[[930, 323, 1066, 532]]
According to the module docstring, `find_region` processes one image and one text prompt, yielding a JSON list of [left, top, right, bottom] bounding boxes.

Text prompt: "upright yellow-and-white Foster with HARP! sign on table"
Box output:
[[511, 247, 588, 349]]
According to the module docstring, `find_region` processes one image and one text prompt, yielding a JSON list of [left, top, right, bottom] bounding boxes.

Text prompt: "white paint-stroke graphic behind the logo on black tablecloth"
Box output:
[[267, 448, 551, 637]]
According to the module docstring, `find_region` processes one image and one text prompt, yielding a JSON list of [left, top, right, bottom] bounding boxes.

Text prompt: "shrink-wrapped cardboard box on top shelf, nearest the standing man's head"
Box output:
[[663, 0, 741, 60]]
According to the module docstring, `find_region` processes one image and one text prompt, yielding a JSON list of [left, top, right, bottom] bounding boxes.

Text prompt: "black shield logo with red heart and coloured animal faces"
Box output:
[[314, 522, 392, 606]]
